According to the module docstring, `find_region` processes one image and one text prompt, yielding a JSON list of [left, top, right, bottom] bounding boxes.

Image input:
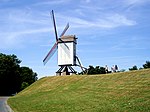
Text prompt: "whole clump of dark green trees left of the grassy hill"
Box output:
[[0, 53, 38, 96]]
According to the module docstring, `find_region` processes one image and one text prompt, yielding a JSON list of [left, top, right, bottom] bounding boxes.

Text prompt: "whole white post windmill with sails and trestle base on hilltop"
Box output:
[[43, 10, 85, 75]]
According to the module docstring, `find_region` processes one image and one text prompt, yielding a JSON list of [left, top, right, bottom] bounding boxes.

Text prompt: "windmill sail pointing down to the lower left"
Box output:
[[43, 43, 57, 65]]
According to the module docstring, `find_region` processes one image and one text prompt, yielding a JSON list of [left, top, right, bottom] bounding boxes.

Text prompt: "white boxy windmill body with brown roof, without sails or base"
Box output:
[[58, 35, 77, 66]]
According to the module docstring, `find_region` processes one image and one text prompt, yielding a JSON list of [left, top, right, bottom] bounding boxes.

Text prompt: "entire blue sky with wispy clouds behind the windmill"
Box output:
[[0, 0, 150, 78]]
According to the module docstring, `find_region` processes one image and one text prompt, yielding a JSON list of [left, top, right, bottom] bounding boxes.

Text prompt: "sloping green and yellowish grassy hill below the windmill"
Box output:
[[8, 69, 150, 112]]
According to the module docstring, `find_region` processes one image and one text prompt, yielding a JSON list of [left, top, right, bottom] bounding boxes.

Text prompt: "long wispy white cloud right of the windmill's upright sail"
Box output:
[[58, 14, 136, 29]]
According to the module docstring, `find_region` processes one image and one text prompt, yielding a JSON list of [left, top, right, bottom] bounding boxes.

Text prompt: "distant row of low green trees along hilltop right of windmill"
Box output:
[[79, 61, 150, 75]]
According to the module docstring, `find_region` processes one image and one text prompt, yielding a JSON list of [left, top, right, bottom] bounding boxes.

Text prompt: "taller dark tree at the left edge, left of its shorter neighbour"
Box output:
[[0, 53, 21, 95]]
